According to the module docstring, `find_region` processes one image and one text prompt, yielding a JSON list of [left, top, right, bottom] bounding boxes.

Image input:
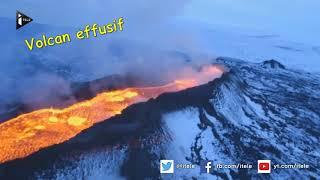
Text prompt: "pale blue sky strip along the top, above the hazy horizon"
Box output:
[[0, 0, 320, 45]]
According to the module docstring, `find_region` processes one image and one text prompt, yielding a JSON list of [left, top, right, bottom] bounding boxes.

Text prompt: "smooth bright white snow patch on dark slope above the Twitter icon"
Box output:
[[162, 107, 238, 179]]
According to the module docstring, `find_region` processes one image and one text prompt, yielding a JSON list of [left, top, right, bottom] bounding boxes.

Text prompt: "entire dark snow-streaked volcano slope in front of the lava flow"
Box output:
[[0, 58, 320, 179]]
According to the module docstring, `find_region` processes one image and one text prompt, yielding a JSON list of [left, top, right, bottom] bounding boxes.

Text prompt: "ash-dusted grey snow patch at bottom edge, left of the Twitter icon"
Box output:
[[35, 148, 126, 180]]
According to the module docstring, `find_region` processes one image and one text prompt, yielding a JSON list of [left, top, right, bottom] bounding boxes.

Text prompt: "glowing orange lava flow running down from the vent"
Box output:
[[0, 66, 223, 163]]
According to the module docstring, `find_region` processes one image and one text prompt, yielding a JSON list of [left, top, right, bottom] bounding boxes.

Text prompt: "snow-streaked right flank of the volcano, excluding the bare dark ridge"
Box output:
[[164, 58, 320, 179]]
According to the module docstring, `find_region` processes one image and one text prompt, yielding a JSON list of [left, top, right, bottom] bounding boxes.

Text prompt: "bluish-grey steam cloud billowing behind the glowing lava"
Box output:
[[0, 0, 216, 119]]
